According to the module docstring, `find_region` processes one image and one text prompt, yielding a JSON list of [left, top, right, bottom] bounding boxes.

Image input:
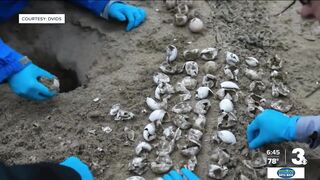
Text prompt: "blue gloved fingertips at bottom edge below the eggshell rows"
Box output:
[[163, 168, 200, 180]]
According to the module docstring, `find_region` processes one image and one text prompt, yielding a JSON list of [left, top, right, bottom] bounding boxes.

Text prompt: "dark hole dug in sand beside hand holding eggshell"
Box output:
[[31, 50, 81, 92]]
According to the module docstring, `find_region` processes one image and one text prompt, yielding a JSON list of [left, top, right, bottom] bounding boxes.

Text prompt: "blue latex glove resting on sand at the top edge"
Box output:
[[108, 2, 146, 31]]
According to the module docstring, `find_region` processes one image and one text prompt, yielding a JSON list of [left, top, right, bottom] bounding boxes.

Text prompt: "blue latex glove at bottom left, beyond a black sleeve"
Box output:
[[60, 156, 93, 180]]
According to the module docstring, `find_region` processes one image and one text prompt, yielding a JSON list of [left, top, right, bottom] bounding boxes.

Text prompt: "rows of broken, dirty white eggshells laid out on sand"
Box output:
[[128, 45, 291, 180]]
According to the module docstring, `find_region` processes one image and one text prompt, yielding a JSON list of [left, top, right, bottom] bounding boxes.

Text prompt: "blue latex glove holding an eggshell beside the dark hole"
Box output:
[[8, 64, 56, 101]]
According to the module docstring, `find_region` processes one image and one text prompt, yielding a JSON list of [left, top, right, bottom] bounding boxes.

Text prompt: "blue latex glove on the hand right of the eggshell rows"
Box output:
[[247, 109, 300, 149]]
